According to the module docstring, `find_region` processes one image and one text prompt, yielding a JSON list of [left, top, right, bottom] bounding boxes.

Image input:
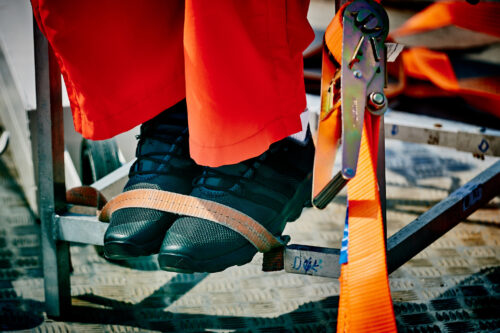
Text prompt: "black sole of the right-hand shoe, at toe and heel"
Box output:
[[158, 174, 312, 273]]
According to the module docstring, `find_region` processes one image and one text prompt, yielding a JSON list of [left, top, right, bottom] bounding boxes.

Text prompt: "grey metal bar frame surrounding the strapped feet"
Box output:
[[32, 10, 500, 317]]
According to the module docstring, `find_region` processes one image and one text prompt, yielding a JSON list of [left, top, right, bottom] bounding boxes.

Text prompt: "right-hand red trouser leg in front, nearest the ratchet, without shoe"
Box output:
[[184, 0, 314, 167]]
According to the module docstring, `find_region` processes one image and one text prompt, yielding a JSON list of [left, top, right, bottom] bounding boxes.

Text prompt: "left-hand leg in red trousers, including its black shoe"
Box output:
[[32, 0, 200, 259]]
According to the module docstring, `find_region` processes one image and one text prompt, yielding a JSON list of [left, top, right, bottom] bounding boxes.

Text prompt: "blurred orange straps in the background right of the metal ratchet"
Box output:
[[391, 1, 500, 117]]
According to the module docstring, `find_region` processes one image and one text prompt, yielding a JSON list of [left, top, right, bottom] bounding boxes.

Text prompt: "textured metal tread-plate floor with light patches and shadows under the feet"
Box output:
[[0, 141, 500, 332]]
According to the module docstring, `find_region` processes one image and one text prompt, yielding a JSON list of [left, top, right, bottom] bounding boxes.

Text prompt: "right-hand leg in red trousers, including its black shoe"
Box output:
[[159, 0, 314, 272]]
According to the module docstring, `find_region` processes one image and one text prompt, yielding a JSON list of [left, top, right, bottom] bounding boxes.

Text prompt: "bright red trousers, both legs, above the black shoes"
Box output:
[[32, 0, 313, 166]]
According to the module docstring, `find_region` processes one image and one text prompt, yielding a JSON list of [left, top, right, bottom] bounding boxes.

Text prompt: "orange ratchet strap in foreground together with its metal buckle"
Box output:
[[313, 0, 396, 332]]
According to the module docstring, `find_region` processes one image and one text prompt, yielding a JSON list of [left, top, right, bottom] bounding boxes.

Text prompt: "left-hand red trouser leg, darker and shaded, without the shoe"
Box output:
[[32, 0, 185, 140]]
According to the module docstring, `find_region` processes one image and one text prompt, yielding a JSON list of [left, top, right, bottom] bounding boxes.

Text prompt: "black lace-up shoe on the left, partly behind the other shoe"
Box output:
[[104, 101, 201, 259]]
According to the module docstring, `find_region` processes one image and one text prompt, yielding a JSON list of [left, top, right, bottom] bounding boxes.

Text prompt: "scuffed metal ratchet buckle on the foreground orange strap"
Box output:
[[313, 0, 389, 208]]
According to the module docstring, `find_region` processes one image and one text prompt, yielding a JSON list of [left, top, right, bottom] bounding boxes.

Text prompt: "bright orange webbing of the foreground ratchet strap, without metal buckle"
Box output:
[[315, 1, 397, 332]]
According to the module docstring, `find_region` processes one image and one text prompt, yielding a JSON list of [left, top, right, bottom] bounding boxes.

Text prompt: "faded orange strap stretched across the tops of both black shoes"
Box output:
[[99, 189, 284, 253]]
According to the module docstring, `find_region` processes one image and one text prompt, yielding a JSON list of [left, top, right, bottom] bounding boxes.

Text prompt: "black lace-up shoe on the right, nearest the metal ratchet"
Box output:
[[158, 135, 314, 273]]
